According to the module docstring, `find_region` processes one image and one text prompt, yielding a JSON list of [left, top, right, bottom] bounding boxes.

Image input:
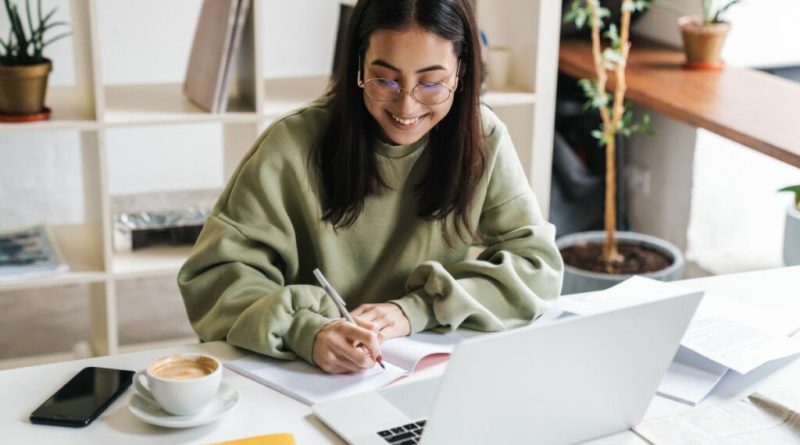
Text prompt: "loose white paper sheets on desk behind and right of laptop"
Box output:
[[561, 277, 800, 405]]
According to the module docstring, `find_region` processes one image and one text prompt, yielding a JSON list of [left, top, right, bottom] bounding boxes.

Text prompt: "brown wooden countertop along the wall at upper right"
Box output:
[[558, 39, 800, 167]]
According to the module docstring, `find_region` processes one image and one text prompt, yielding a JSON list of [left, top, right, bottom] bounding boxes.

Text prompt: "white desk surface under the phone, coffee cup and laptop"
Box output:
[[0, 266, 800, 445]]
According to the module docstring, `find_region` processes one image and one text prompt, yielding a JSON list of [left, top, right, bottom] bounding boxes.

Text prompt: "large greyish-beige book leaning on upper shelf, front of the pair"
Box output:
[[183, 0, 240, 113]]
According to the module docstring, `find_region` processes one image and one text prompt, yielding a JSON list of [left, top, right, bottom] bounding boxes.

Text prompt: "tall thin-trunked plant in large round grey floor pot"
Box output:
[[556, 0, 685, 293]]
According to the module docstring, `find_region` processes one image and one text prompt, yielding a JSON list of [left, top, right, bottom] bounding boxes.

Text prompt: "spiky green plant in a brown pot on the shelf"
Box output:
[[0, 0, 69, 121]]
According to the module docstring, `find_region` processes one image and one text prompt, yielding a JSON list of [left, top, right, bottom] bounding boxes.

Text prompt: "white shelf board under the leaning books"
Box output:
[[103, 83, 258, 125]]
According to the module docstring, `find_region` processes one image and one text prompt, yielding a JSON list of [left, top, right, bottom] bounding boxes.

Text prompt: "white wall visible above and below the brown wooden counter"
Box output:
[[629, 0, 800, 273]]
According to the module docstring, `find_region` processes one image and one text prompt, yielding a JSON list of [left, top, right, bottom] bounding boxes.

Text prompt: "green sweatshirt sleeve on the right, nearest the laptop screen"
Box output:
[[393, 112, 564, 332]]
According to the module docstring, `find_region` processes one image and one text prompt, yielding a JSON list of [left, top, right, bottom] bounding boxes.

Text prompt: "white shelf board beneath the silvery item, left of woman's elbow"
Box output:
[[112, 246, 192, 278]]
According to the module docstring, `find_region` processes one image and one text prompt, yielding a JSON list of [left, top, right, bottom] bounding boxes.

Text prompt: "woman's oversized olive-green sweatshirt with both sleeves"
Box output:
[[178, 98, 563, 362]]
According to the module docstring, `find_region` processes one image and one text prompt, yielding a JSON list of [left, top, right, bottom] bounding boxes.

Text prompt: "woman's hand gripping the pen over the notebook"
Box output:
[[311, 319, 381, 374]]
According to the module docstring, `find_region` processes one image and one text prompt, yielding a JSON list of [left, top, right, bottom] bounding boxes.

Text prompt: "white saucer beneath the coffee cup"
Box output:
[[128, 382, 239, 428]]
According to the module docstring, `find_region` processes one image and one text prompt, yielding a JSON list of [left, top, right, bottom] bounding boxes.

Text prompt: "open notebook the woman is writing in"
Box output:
[[225, 332, 463, 405]]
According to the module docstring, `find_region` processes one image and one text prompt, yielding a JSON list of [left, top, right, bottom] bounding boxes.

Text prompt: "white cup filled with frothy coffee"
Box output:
[[133, 353, 222, 416]]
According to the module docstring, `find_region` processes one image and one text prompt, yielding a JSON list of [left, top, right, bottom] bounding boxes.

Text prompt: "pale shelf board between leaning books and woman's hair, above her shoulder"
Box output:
[[264, 76, 330, 119]]
